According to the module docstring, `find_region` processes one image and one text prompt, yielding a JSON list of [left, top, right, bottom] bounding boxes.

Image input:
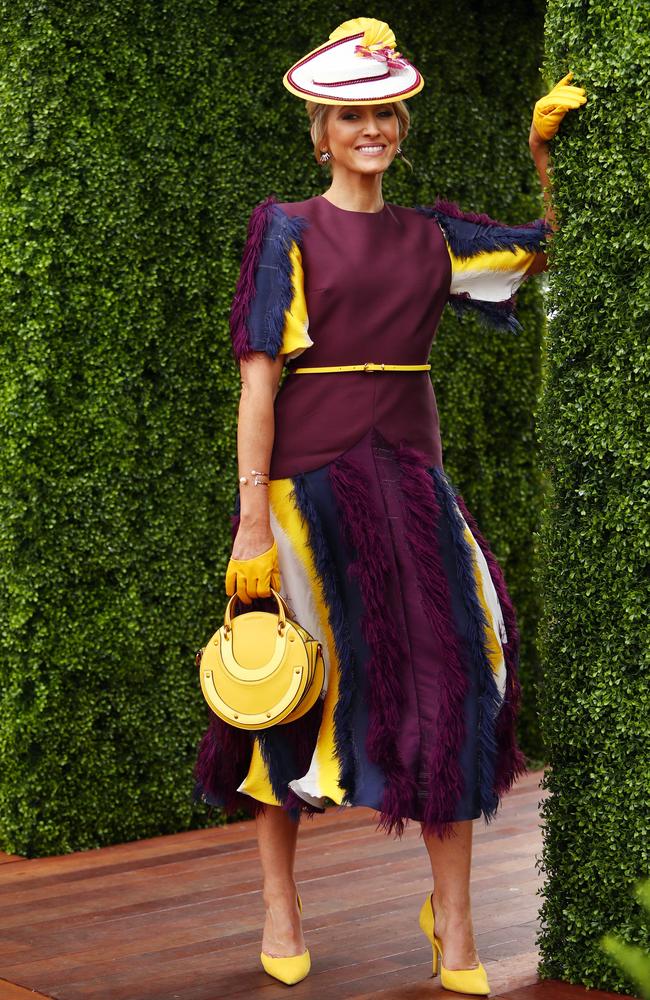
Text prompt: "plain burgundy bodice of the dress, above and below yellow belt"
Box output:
[[270, 195, 451, 479]]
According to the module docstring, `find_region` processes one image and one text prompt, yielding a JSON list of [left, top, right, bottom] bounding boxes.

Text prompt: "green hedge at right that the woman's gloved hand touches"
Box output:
[[541, 0, 650, 992]]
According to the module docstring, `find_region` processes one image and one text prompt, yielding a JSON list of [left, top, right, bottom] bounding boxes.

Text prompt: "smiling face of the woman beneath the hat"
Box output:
[[321, 104, 399, 174]]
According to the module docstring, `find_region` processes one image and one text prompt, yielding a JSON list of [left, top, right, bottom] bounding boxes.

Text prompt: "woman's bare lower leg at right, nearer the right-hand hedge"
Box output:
[[424, 820, 479, 969]]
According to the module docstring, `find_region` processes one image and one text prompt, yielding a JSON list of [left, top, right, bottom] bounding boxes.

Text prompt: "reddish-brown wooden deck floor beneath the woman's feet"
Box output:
[[0, 772, 628, 1000]]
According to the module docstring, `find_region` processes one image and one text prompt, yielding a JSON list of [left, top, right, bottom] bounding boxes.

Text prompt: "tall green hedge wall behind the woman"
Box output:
[[0, 0, 543, 855]]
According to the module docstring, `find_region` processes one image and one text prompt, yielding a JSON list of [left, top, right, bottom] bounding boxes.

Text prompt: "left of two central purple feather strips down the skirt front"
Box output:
[[329, 458, 417, 837]]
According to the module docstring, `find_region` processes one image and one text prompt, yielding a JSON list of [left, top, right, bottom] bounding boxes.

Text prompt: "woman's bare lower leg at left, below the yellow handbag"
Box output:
[[256, 805, 305, 958]]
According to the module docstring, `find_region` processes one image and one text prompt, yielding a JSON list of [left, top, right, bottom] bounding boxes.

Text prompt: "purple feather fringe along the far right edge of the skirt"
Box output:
[[456, 494, 528, 796]]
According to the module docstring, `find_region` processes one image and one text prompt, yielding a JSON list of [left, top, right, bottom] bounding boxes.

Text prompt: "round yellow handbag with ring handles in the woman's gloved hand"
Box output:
[[196, 588, 325, 729]]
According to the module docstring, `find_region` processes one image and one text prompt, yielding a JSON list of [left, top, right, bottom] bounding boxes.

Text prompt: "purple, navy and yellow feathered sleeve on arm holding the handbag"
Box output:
[[230, 196, 313, 360]]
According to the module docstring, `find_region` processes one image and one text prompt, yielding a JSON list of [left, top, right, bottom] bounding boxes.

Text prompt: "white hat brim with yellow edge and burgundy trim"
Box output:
[[282, 32, 424, 104]]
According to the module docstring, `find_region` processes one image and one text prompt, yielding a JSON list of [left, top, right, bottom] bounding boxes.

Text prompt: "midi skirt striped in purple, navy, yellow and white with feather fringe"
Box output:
[[194, 428, 526, 836]]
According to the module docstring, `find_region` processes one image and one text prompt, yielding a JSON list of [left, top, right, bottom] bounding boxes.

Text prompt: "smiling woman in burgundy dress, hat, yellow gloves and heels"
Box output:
[[192, 18, 585, 994]]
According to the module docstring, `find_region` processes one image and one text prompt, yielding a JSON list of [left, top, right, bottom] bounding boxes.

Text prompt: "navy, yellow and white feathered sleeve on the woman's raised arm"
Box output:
[[417, 199, 550, 332]]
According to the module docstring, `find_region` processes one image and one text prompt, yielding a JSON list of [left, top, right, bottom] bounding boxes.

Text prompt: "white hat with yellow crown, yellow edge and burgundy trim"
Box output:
[[282, 17, 424, 104]]
